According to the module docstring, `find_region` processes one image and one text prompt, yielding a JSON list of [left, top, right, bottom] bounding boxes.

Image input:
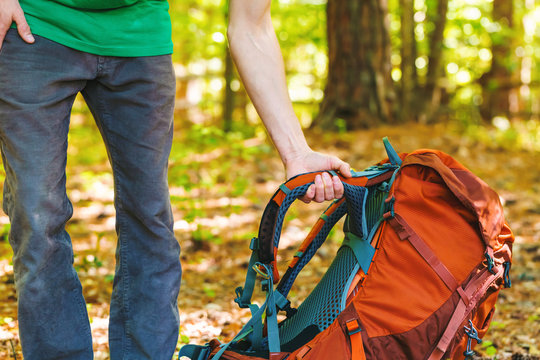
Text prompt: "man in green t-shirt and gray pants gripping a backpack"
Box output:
[[0, 0, 348, 360]]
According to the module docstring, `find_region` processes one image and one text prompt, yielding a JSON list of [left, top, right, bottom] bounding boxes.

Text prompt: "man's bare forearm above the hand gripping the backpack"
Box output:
[[228, 2, 310, 164]]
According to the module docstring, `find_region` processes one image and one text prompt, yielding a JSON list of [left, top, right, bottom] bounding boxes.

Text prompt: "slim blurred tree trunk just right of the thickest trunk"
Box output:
[[400, 0, 417, 121]]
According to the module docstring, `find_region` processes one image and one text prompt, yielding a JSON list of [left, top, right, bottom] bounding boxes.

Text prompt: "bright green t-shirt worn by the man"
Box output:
[[19, 0, 173, 57]]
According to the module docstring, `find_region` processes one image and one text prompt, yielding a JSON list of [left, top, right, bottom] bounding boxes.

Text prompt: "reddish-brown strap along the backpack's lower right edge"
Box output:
[[428, 266, 504, 360]]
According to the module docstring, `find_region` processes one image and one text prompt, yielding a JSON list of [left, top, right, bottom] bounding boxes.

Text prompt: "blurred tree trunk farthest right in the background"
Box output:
[[480, 0, 514, 121]]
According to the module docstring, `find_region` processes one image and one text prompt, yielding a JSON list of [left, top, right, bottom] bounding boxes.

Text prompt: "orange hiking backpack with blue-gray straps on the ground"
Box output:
[[179, 138, 514, 360]]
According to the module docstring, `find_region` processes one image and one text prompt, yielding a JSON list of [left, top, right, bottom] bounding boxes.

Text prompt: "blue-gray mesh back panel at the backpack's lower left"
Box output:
[[279, 247, 357, 344]]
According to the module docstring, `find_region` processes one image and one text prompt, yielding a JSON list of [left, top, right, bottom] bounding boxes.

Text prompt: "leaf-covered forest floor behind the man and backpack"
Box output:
[[0, 124, 540, 360]]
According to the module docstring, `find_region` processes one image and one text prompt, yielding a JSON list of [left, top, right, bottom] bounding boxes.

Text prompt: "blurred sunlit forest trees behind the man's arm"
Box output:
[[171, 0, 540, 146]]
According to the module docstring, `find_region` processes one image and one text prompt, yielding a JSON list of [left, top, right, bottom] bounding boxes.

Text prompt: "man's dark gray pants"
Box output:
[[0, 29, 181, 360]]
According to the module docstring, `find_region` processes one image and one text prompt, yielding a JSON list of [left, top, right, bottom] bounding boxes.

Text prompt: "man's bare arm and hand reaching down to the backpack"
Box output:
[[227, 0, 351, 202]]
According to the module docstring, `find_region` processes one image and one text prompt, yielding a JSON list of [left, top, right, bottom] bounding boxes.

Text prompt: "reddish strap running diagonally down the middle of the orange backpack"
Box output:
[[384, 213, 459, 292]]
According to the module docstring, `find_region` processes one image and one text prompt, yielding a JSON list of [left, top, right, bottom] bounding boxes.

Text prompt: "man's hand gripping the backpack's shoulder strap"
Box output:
[[285, 151, 352, 203]]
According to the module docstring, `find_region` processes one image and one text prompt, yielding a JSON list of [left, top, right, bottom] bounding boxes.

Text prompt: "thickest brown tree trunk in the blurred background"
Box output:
[[314, 0, 395, 129]]
